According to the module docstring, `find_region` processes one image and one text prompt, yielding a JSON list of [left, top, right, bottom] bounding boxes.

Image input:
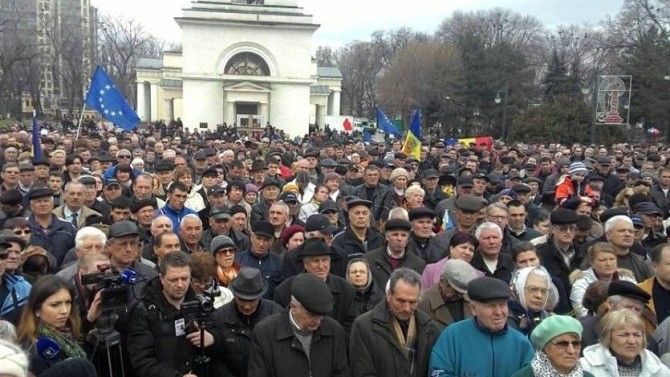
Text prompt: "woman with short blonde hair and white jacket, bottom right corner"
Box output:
[[580, 310, 670, 377]]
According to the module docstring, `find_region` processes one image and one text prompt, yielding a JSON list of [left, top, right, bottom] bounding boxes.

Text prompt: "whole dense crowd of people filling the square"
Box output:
[[0, 122, 670, 377]]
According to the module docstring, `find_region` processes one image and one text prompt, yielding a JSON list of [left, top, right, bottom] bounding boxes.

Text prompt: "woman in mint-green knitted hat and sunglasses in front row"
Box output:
[[512, 315, 593, 377]]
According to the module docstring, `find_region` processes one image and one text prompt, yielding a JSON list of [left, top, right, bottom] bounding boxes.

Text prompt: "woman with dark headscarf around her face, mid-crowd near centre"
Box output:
[[347, 258, 384, 317]]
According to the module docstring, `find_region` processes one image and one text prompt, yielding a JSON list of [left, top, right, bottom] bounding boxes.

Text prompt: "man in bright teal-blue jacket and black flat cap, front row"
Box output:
[[427, 276, 534, 377]]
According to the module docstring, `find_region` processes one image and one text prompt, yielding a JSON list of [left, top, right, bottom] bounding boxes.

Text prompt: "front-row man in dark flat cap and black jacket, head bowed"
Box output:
[[248, 273, 351, 377]]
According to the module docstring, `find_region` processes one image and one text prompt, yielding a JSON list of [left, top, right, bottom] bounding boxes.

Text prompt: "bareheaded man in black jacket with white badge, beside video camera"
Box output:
[[127, 251, 215, 377]]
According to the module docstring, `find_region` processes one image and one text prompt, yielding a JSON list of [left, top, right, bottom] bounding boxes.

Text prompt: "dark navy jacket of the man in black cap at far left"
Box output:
[[28, 215, 77, 271]]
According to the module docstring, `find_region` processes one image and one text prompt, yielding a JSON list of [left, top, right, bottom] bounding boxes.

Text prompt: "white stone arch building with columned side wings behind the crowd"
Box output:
[[137, 0, 342, 136]]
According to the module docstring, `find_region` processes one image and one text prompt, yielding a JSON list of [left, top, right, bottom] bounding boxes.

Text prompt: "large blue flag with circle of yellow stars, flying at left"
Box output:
[[86, 66, 140, 131]]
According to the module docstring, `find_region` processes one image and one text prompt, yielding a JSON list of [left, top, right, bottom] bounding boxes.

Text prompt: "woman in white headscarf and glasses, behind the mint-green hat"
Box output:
[[507, 267, 551, 335]]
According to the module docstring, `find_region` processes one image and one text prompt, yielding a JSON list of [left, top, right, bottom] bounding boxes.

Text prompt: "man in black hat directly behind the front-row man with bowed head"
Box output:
[[274, 238, 356, 332]]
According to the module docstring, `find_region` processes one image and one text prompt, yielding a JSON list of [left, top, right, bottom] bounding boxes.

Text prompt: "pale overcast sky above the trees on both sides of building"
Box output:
[[91, 0, 623, 49]]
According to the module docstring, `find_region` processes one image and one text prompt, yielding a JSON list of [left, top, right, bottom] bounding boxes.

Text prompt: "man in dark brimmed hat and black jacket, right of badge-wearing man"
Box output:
[[211, 267, 284, 377]]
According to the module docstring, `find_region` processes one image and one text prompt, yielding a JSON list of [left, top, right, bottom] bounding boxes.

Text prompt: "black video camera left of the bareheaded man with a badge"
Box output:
[[81, 268, 138, 311]]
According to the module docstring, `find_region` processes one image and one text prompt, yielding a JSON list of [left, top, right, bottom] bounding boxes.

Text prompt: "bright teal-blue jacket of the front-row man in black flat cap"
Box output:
[[428, 317, 535, 377]]
